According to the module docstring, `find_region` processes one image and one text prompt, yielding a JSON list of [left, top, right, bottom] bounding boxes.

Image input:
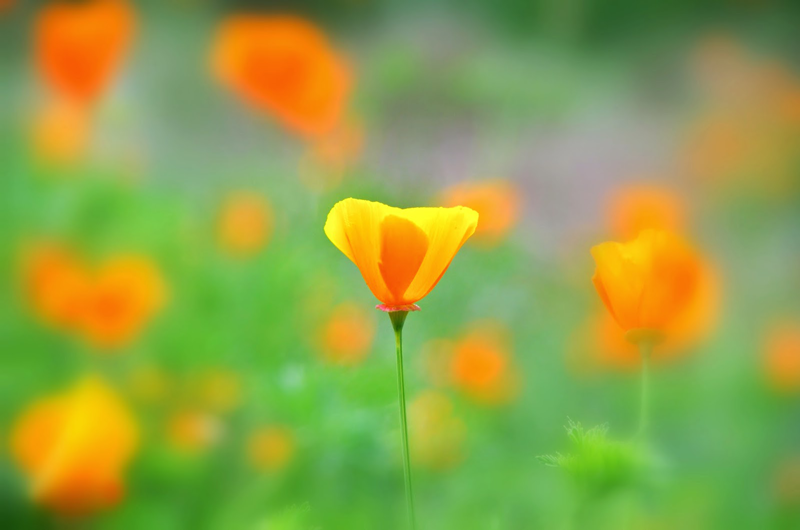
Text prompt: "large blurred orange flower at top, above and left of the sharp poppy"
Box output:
[[212, 15, 351, 136]]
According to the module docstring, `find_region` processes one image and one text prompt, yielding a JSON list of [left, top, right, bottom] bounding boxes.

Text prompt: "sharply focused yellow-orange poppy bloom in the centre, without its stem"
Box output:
[[325, 199, 478, 311]]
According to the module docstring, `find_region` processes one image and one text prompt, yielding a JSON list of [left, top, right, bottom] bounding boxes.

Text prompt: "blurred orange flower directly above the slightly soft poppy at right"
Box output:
[[607, 185, 685, 239]]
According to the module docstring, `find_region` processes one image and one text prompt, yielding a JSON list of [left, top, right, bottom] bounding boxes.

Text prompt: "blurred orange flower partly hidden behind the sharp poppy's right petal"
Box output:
[[442, 179, 522, 246]]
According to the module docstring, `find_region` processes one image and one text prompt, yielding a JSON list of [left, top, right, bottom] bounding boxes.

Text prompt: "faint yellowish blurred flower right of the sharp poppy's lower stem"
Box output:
[[409, 391, 466, 470]]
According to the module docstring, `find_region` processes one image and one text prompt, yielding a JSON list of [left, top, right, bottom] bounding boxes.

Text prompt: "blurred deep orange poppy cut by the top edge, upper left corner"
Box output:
[[34, 0, 134, 102]]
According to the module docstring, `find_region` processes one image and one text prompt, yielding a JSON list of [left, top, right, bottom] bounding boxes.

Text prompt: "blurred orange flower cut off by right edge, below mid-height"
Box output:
[[764, 324, 800, 393]]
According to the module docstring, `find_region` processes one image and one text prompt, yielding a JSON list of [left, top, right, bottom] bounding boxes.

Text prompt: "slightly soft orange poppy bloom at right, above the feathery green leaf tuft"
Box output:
[[592, 230, 703, 340]]
